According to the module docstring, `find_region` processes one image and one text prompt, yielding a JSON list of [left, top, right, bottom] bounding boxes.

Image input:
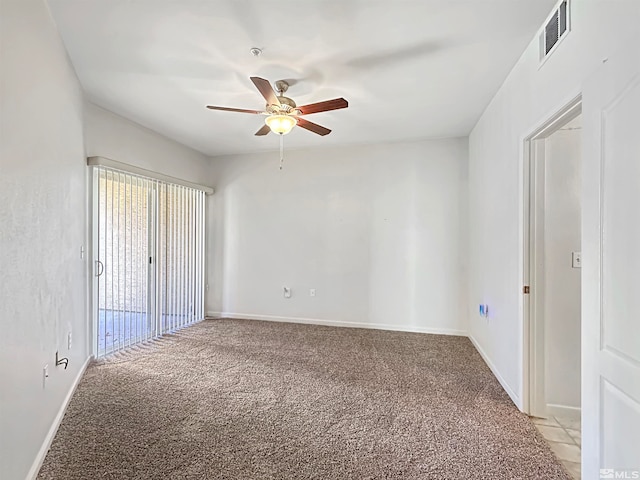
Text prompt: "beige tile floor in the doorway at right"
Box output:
[[531, 417, 581, 480]]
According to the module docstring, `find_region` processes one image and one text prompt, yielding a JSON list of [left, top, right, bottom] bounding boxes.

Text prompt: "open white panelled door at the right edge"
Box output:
[[582, 41, 640, 479]]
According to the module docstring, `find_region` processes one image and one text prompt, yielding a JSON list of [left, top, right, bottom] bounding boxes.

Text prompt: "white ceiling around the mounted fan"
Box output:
[[49, 0, 556, 155]]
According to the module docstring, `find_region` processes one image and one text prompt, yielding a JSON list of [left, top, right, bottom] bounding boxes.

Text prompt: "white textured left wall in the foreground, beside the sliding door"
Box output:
[[0, 0, 88, 480]]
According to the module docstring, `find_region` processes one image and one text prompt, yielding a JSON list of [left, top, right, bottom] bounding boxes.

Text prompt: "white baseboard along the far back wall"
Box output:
[[207, 312, 467, 337]]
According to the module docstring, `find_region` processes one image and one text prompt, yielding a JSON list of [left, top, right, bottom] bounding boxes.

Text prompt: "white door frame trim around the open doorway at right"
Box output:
[[521, 94, 582, 418]]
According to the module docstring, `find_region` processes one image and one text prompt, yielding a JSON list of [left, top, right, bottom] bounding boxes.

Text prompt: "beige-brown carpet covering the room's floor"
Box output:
[[38, 320, 569, 480]]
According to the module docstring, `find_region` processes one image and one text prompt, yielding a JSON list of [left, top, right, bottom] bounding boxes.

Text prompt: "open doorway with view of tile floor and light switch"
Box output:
[[523, 98, 582, 469]]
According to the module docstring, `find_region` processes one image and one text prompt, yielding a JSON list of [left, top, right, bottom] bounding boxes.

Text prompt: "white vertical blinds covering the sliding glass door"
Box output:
[[94, 167, 205, 356]]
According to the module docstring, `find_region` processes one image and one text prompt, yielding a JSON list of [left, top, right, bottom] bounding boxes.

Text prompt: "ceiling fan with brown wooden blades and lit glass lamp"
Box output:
[[207, 77, 349, 136]]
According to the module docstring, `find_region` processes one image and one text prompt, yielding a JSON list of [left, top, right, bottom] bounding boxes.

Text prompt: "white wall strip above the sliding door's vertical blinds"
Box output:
[[84, 102, 210, 184]]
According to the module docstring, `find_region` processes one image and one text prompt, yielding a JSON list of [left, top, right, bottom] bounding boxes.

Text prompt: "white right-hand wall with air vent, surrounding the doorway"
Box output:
[[468, 0, 640, 407]]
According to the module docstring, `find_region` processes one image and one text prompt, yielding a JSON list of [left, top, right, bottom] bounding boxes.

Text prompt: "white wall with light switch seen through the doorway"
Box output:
[[543, 122, 582, 416]]
